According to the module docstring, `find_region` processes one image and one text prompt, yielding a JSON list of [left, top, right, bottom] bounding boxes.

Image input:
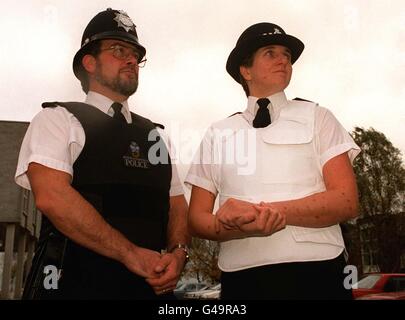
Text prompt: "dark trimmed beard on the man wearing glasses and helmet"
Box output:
[[94, 63, 138, 97]]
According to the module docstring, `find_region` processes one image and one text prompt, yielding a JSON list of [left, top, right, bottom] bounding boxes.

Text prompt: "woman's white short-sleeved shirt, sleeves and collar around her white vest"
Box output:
[[185, 92, 360, 195]]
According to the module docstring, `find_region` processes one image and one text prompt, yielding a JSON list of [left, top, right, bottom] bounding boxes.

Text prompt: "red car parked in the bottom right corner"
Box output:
[[353, 273, 405, 300]]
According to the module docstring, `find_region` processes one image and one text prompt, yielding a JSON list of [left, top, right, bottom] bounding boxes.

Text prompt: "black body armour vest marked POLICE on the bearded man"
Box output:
[[38, 102, 172, 298]]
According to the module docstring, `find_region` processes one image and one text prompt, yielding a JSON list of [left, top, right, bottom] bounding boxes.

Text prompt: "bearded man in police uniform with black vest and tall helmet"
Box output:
[[16, 9, 190, 299]]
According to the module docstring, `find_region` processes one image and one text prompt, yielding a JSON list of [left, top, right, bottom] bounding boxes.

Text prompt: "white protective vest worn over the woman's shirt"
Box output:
[[214, 100, 344, 271]]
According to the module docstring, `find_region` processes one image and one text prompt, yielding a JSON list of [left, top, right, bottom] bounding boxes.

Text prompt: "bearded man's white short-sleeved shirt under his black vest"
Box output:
[[15, 91, 184, 196]]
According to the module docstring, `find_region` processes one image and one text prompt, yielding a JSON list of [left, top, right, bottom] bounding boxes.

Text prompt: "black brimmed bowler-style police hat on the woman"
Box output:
[[226, 22, 304, 83]]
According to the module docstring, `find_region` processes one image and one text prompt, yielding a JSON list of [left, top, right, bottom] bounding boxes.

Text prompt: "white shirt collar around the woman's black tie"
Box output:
[[242, 91, 288, 125]]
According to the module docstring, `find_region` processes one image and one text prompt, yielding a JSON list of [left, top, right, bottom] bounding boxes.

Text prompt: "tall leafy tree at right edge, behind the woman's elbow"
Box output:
[[348, 127, 405, 272]]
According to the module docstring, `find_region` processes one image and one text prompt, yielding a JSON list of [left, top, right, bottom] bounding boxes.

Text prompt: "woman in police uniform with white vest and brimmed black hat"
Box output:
[[186, 23, 360, 299]]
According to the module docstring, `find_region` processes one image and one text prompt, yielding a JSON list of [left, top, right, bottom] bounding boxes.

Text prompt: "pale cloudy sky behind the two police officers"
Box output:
[[0, 0, 405, 180]]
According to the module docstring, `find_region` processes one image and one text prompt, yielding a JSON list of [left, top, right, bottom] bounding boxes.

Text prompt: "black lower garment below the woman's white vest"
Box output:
[[221, 254, 352, 300]]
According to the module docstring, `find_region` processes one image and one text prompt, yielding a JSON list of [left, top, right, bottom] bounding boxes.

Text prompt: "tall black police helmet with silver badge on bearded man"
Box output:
[[73, 8, 146, 79]]
